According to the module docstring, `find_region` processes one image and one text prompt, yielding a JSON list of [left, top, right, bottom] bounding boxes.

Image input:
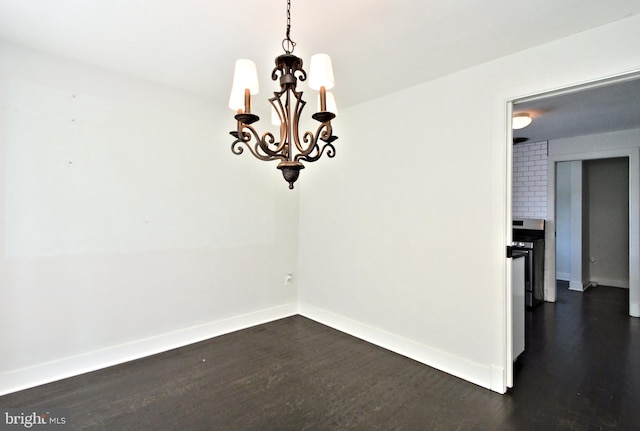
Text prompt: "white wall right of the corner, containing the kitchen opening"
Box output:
[[300, 17, 640, 392]]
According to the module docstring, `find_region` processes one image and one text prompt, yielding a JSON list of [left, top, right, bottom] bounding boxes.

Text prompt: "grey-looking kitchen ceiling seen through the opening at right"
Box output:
[[513, 76, 640, 142]]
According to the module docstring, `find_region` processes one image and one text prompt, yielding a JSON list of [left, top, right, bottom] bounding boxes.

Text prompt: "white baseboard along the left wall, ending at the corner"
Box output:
[[0, 303, 298, 395]]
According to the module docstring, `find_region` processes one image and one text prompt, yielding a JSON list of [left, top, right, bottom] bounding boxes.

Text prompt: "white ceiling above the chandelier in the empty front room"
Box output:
[[0, 0, 640, 113]]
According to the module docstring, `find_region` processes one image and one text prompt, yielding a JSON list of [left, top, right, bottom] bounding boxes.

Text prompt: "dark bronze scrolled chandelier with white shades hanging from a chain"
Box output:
[[229, 0, 338, 189]]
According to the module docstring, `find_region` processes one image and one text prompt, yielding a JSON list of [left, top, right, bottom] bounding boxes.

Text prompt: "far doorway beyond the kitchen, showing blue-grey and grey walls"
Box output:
[[555, 157, 629, 292]]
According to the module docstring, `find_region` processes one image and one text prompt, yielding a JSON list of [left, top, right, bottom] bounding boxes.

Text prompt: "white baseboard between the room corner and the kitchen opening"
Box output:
[[299, 303, 496, 393]]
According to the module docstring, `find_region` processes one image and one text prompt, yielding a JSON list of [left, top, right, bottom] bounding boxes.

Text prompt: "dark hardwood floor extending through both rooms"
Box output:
[[0, 287, 640, 431]]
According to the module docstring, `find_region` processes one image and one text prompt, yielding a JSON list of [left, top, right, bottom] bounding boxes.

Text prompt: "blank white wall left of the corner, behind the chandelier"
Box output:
[[0, 44, 298, 393]]
